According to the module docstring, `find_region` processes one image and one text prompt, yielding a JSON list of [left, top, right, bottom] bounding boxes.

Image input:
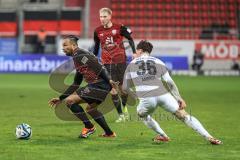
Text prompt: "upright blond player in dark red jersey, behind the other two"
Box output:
[[94, 8, 136, 122]]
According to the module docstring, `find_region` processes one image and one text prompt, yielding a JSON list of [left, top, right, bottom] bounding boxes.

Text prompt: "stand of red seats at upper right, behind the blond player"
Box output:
[[111, 0, 240, 40]]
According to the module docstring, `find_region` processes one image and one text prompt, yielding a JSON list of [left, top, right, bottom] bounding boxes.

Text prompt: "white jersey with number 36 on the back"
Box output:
[[123, 54, 170, 98]]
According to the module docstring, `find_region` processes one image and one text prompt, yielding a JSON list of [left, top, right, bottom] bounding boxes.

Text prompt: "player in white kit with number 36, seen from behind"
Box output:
[[122, 40, 222, 145]]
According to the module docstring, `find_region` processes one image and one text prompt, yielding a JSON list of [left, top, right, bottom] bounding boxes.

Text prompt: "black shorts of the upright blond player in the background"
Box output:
[[104, 63, 127, 84]]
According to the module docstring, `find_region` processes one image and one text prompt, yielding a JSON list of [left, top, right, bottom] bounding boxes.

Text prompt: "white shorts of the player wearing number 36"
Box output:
[[137, 93, 179, 117]]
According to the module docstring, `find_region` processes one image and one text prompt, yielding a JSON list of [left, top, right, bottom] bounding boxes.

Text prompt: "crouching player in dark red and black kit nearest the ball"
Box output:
[[49, 36, 117, 138]]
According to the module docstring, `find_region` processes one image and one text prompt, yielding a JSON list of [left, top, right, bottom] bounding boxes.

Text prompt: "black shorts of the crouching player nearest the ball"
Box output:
[[76, 81, 112, 104]]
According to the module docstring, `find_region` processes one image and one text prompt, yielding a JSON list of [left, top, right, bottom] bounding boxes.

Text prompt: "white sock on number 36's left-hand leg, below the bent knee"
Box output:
[[143, 115, 168, 137]]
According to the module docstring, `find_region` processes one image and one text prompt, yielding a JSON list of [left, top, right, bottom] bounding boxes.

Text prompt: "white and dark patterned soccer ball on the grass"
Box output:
[[16, 123, 32, 139]]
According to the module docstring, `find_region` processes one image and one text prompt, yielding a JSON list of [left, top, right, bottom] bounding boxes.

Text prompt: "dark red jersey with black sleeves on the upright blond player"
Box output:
[[94, 23, 135, 64]]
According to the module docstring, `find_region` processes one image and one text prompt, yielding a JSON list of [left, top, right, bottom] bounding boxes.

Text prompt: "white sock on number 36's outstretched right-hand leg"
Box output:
[[184, 115, 212, 139]]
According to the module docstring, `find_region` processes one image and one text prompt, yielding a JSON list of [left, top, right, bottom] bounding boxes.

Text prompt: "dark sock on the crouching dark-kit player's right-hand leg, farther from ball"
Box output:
[[88, 108, 113, 135]]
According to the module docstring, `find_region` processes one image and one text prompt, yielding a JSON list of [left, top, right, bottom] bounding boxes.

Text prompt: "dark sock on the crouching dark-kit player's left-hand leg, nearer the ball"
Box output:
[[69, 104, 94, 128]]
